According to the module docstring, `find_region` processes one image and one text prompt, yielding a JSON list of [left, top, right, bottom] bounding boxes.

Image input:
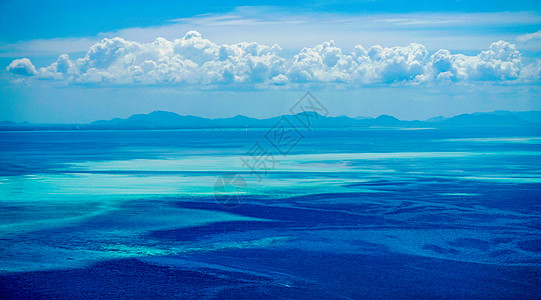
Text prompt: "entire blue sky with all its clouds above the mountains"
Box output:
[[0, 0, 541, 123]]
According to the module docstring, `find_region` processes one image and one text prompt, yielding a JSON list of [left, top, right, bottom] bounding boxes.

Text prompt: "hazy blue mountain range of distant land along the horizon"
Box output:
[[0, 111, 541, 131]]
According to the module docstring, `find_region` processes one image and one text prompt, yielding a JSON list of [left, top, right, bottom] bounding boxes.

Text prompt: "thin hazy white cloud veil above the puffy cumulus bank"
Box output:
[[0, 7, 541, 57]]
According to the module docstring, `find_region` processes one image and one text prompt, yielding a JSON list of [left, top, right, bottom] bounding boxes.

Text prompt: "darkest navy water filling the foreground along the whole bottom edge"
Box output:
[[0, 249, 541, 299]]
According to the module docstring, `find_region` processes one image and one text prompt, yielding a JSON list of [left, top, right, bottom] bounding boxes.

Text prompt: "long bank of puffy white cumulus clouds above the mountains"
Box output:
[[8, 31, 539, 87]]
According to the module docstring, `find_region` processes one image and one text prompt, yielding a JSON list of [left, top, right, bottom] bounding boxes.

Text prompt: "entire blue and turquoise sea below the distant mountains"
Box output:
[[0, 127, 541, 299]]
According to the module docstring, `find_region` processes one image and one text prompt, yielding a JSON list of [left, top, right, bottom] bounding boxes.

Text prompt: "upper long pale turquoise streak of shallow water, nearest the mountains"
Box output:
[[66, 151, 541, 173]]
